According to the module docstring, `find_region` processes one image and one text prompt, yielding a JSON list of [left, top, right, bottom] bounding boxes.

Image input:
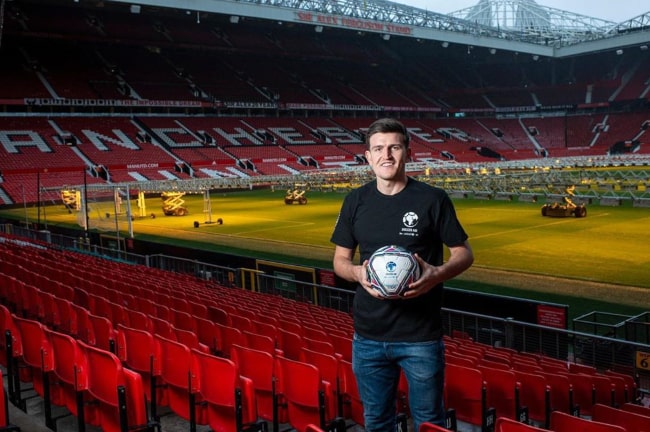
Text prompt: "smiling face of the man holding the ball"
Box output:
[[366, 132, 411, 180]]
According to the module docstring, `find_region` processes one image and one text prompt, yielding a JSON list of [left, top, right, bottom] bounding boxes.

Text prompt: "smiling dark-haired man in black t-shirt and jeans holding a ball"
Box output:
[[331, 119, 474, 432]]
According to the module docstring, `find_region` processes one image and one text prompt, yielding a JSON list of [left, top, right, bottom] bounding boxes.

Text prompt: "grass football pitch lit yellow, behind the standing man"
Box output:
[[0, 189, 650, 318]]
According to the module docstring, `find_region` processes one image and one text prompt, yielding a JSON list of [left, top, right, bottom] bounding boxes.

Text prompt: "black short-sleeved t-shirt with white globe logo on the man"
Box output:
[[331, 178, 467, 342]]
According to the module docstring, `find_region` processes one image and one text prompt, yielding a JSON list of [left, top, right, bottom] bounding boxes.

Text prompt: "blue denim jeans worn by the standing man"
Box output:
[[352, 334, 445, 432]]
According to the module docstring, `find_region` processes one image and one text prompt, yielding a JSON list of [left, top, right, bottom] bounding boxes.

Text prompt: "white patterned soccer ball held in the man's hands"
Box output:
[[368, 246, 420, 298]]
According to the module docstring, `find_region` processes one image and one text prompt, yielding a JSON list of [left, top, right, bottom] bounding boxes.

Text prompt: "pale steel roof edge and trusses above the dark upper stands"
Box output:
[[108, 0, 650, 57]]
